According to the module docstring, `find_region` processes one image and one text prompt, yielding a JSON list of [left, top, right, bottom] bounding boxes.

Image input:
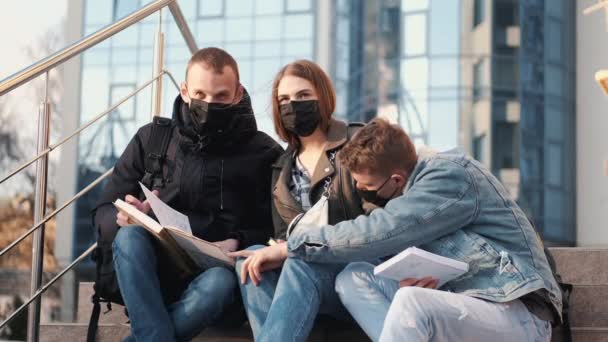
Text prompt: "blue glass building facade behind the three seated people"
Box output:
[[74, 0, 576, 268]]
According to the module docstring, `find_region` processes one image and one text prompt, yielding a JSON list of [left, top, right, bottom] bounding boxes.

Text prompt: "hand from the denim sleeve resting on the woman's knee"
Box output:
[[228, 242, 287, 286]]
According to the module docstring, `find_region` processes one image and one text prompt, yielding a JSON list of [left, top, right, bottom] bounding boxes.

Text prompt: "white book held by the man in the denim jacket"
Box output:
[[374, 247, 469, 288]]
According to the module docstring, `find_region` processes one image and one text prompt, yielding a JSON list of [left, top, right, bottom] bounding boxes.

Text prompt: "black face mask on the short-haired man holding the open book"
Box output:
[[188, 99, 240, 134]]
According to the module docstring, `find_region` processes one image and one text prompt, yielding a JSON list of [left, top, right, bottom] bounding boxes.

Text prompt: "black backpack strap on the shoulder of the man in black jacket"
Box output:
[[141, 116, 174, 190]]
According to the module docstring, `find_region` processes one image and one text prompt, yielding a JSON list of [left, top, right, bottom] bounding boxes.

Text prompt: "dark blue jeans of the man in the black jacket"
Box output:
[[112, 226, 237, 342]]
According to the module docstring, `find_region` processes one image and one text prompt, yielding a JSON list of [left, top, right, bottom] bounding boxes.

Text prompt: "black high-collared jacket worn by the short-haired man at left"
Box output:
[[93, 92, 283, 249]]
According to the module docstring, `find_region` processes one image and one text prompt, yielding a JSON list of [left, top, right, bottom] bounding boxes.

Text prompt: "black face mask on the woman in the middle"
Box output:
[[279, 100, 321, 137]]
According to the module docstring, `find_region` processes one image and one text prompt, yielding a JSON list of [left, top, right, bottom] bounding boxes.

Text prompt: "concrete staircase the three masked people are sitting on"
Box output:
[[40, 248, 608, 342]]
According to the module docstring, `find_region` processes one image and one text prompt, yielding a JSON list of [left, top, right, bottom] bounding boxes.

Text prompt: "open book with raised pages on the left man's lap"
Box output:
[[114, 183, 235, 273]]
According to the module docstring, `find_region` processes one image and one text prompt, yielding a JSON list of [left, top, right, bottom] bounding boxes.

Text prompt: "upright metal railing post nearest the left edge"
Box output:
[[27, 71, 51, 342]]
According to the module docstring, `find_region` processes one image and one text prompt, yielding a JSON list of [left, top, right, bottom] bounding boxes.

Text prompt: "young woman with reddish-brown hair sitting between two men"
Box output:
[[228, 60, 364, 341]]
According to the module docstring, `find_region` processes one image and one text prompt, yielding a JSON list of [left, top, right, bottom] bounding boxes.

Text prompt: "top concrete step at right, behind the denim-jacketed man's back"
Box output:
[[550, 247, 608, 285]]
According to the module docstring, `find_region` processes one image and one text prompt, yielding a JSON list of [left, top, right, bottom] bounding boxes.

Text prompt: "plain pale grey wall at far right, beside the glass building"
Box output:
[[566, 0, 608, 246]]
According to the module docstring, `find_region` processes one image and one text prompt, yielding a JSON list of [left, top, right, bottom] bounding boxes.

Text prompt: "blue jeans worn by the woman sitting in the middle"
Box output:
[[236, 245, 349, 342]]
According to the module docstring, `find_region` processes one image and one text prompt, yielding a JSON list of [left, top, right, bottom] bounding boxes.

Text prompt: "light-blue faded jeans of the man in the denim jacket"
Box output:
[[336, 262, 551, 342]]
